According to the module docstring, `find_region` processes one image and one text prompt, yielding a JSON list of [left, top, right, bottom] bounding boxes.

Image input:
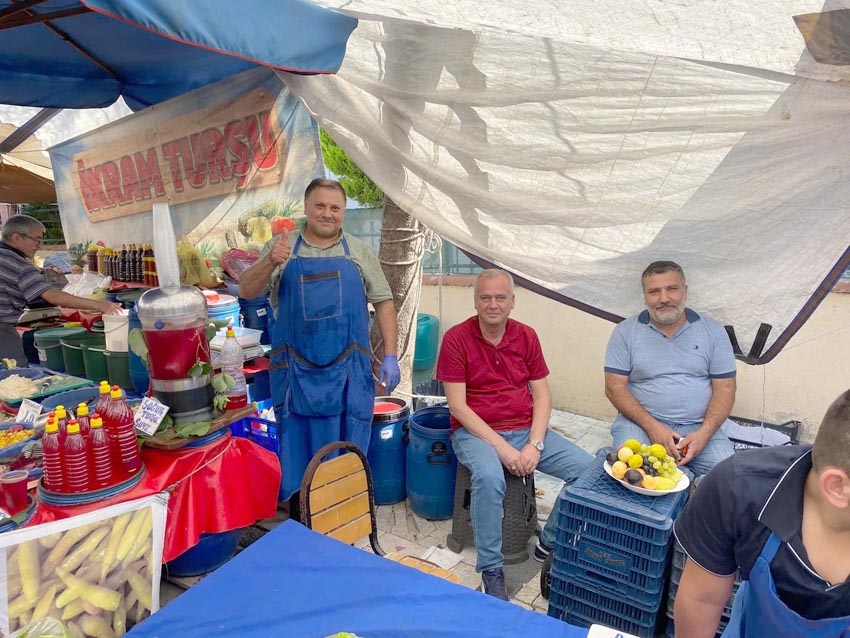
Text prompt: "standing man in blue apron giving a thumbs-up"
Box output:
[[239, 178, 401, 501]]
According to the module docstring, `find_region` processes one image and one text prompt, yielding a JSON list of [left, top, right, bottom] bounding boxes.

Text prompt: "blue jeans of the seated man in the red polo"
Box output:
[[452, 428, 593, 572]]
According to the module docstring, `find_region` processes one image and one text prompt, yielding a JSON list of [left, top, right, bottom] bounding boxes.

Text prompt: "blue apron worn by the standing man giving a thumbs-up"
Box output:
[[269, 235, 375, 500]]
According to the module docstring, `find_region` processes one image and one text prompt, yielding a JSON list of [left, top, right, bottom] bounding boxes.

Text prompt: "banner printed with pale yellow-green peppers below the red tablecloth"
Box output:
[[0, 494, 168, 638]]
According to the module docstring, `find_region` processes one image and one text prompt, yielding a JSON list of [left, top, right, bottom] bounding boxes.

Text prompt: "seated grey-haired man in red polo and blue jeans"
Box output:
[[437, 268, 593, 600]]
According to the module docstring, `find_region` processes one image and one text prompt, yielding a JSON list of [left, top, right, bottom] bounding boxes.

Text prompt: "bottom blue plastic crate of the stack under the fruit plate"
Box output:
[[549, 574, 663, 636]]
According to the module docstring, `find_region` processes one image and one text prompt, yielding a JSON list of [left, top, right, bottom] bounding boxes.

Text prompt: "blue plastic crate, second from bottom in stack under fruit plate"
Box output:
[[552, 542, 667, 609]]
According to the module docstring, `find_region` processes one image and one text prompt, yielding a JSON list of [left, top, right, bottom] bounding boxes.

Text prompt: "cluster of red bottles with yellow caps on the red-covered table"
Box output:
[[42, 381, 142, 493]]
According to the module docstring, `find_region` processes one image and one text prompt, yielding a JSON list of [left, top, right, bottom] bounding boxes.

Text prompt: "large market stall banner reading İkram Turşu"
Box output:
[[50, 68, 323, 268]]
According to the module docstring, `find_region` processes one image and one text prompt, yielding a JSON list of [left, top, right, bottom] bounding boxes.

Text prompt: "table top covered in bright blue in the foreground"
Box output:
[[127, 521, 587, 638]]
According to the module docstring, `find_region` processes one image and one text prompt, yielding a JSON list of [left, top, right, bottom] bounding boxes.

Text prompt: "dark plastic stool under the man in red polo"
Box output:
[[446, 463, 537, 565]]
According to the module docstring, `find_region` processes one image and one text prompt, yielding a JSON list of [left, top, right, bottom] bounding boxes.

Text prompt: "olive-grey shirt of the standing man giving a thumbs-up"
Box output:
[[260, 230, 393, 316]]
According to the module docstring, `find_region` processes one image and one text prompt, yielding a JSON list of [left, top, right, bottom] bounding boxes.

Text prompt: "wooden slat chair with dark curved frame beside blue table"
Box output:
[[300, 441, 460, 583]]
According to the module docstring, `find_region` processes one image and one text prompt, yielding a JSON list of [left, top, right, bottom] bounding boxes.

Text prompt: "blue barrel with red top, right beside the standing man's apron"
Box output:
[[366, 397, 410, 505]]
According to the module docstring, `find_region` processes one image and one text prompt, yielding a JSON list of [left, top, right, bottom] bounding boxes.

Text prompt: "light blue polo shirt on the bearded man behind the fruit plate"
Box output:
[[605, 308, 736, 425]]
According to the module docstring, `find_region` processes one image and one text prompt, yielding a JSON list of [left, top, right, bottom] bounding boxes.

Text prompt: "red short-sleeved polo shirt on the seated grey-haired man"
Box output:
[[437, 315, 549, 431]]
